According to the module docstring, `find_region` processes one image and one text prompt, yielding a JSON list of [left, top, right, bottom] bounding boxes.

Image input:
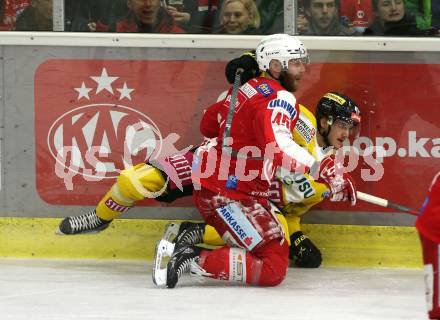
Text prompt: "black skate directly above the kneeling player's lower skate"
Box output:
[[162, 221, 206, 245]]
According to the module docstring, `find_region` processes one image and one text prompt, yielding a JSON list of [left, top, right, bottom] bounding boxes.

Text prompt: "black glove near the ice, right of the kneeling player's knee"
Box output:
[[289, 231, 322, 268]]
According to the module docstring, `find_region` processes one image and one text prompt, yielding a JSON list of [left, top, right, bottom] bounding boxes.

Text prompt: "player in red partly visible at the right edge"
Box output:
[[416, 172, 440, 319]]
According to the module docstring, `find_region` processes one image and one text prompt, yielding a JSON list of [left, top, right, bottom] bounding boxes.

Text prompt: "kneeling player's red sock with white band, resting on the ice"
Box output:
[[200, 240, 289, 286]]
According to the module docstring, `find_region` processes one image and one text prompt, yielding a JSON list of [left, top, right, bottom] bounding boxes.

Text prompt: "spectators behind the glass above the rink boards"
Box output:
[[0, 0, 440, 36]]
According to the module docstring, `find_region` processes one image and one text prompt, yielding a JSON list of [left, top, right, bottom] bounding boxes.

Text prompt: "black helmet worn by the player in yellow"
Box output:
[[316, 92, 361, 144]]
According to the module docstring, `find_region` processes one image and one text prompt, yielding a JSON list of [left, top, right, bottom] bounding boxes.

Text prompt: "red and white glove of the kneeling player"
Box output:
[[317, 156, 357, 206]]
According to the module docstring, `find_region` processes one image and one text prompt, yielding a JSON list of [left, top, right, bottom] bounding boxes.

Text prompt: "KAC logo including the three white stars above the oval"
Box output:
[[47, 68, 162, 190]]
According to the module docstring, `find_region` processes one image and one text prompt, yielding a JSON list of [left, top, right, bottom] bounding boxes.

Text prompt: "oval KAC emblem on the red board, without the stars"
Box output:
[[47, 104, 161, 178]]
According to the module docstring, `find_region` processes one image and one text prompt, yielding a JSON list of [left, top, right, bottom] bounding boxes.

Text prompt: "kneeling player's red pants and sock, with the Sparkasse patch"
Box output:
[[194, 188, 289, 286]]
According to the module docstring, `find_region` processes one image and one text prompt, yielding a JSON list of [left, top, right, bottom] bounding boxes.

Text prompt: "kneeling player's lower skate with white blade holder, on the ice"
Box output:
[[153, 239, 209, 288]]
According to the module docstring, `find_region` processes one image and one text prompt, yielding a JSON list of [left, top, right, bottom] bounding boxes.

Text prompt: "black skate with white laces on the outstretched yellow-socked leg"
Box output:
[[57, 210, 111, 235]]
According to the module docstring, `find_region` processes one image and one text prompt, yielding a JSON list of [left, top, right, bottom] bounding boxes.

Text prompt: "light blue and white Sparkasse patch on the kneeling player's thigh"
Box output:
[[216, 203, 263, 250]]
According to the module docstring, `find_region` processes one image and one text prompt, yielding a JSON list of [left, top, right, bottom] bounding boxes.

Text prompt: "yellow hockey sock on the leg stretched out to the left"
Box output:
[[96, 163, 165, 221]]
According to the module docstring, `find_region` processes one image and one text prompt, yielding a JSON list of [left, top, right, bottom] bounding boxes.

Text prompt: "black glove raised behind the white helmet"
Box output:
[[225, 52, 261, 84]]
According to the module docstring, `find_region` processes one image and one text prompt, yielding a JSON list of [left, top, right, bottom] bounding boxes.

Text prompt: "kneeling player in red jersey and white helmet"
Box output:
[[153, 34, 355, 288]]
